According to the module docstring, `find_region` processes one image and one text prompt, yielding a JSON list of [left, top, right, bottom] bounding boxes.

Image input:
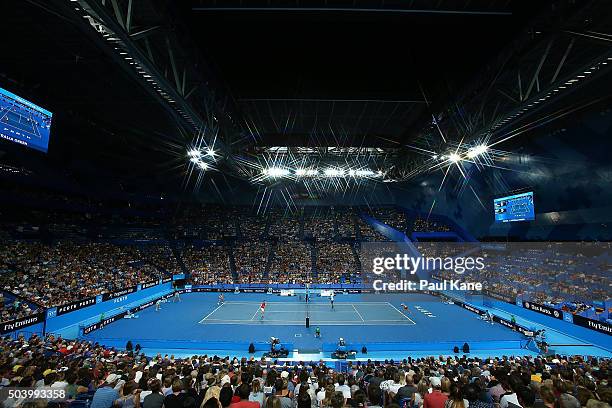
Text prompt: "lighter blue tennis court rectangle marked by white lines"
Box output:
[[200, 301, 416, 326]]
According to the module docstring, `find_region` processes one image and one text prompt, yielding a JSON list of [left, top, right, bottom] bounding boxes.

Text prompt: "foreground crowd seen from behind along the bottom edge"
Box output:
[[0, 336, 612, 408]]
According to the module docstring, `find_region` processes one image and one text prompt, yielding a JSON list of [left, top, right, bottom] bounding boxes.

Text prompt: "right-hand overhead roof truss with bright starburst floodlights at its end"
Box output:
[[400, 2, 612, 180]]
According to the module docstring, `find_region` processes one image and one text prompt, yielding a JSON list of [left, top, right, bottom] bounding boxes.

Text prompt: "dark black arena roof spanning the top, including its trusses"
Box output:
[[0, 0, 610, 197]]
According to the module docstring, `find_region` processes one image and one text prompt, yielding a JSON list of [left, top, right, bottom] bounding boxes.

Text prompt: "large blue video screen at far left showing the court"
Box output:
[[0, 88, 53, 153]]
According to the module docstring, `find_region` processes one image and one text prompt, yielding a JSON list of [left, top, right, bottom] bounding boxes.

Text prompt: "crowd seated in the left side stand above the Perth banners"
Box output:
[[0, 241, 162, 307]]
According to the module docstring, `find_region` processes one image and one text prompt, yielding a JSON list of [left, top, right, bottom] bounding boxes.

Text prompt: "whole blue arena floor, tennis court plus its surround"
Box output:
[[85, 293, 548, 356]]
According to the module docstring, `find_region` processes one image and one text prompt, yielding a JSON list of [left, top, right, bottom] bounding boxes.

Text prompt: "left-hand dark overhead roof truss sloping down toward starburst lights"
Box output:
[[59, 0, 234, 155]]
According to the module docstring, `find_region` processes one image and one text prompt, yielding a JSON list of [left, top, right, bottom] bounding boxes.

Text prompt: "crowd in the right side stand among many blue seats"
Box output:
[[424, 242, 612, 320]]
